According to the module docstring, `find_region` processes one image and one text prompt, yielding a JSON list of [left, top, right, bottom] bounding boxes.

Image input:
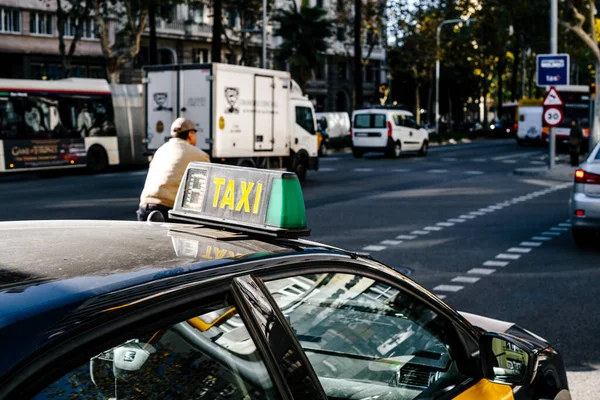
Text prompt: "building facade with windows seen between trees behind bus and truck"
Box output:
[[0, 0, 386, 112]]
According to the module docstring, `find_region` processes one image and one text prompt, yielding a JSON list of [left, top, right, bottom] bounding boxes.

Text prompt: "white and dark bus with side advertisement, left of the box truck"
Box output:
[[0, 78, 148, 173]]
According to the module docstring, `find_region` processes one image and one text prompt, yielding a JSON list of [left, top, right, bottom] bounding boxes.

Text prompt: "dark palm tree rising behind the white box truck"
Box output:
[[272, 0, 333, 91]]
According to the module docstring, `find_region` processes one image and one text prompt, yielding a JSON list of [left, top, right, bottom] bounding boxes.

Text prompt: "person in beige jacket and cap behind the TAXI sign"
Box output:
[[137, 118, 210, 221]]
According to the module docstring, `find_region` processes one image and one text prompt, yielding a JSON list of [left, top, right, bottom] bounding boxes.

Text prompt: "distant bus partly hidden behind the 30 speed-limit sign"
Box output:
[[542, 85, 594, 148]]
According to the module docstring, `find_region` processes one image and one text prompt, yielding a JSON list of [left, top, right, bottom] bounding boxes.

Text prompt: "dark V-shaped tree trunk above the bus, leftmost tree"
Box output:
[[40, 0, 92, 78]]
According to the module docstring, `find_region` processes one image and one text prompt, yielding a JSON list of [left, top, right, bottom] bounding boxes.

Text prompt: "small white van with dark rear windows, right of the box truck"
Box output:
[[350, 108, 429, 158]]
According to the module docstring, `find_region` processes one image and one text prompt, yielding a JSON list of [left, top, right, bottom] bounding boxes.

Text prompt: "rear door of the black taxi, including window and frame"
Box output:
[[5, 276, 325, 400]]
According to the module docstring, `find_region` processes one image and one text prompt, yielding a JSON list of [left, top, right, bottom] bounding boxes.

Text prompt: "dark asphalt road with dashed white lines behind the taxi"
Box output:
[[0, 141, 600, 399]]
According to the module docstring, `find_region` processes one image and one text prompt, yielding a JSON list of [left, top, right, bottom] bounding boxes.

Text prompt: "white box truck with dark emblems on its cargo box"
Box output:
[[144, 63, 319, 180]]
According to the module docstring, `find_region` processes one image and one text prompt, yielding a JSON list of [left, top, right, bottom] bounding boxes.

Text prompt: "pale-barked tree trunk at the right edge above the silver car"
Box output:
[[561, 0, 600, 149]]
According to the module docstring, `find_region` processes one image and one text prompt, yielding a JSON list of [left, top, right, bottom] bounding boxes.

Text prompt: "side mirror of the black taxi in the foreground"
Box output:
[[479, 332, 538, 385]]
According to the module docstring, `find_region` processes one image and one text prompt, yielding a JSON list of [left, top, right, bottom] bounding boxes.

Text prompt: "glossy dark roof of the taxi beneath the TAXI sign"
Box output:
[[0, 220, 348, 376]]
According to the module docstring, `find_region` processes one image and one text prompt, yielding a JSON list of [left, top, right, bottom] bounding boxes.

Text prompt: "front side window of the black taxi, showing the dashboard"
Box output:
[[267, 273, 466, 399]]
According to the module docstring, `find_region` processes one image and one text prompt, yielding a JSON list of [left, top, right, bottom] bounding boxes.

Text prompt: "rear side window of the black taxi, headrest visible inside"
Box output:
[[34, 302, 276, 400]]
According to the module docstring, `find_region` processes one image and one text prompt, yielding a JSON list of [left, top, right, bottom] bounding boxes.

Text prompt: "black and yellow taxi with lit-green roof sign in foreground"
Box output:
[[0, 163, 570, 400]]
